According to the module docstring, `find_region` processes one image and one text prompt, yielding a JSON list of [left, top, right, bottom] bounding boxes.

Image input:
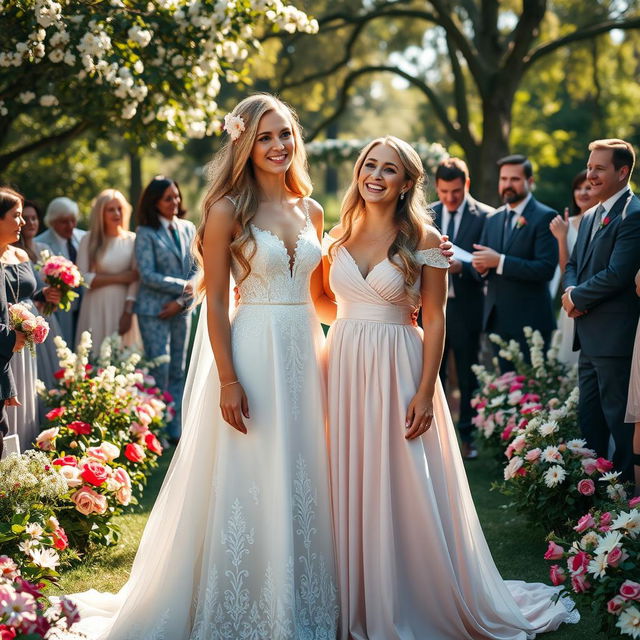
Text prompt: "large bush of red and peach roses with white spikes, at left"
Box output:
[[35, 332, 169, 549]]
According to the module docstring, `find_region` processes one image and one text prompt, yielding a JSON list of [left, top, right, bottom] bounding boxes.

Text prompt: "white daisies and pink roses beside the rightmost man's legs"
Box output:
[[499, 388, 626, 530]]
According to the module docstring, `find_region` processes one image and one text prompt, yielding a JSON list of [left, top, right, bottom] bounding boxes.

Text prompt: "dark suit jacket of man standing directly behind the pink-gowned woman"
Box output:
[[431, 195, 494, 332]]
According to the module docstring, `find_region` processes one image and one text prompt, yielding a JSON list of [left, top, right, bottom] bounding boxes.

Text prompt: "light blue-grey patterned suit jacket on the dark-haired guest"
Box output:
[[135, 218, 196, 316]]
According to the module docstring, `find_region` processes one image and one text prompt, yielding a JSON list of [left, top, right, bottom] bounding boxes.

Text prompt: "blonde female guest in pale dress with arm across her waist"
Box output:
[[76, 189, 142, 356]]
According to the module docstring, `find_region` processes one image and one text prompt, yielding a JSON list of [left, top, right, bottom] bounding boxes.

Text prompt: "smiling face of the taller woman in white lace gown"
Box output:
[[251, 109, 296, 174]]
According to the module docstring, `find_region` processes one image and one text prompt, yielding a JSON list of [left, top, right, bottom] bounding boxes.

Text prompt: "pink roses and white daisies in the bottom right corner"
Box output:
[[545, 498, 640, 638]]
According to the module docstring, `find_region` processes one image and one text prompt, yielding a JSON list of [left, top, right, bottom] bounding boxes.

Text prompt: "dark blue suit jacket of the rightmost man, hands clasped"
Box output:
[[564, 190, 640, 357]]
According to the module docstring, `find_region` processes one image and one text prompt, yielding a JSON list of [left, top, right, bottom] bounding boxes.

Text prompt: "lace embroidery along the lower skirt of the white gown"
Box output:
[[191, 455, 338, 640]]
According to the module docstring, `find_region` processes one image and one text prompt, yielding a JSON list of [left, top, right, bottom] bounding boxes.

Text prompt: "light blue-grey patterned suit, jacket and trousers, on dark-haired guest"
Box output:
[[135, 218, 196, 437]]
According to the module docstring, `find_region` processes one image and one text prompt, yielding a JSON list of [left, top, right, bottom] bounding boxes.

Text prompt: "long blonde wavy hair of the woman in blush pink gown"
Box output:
[[329, 136, 432, 298]]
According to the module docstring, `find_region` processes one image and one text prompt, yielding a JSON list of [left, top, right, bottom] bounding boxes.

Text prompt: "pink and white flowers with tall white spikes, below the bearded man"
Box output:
[[471, 327, 577, 464]]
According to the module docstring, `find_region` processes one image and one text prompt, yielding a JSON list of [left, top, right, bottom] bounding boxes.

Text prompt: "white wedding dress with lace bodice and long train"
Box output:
[[63, 201, 338, 640]]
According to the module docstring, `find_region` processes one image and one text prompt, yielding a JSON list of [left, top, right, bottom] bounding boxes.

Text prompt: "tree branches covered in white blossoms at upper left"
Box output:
[[0, 0, 318, 172]]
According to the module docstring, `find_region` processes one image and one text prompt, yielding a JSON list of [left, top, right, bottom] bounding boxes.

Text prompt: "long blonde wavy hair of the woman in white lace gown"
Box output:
[[192, 93, 312, 299]]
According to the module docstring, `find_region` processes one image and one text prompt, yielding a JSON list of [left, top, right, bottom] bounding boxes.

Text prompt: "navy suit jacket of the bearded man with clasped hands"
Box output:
[[480, 197, 558, 337]]
